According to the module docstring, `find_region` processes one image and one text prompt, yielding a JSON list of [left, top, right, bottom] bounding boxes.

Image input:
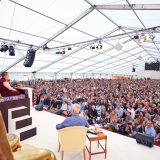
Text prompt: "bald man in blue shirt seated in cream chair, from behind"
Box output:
[[56, 104, 89, 129]]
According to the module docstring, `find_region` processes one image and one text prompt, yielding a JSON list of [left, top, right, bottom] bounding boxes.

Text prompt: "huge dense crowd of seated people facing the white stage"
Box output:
[[16, 79, 160, 141]]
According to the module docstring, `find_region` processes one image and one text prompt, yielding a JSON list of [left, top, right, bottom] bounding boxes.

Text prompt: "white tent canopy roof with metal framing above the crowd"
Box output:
[[0, 0, 160, 75]]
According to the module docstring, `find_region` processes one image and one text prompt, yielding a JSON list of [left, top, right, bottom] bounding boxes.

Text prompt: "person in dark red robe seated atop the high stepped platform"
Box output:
[[0, 72, 20, 97]]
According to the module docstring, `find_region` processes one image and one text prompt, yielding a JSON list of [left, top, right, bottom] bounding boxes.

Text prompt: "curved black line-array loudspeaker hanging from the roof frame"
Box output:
[[23, 49, 36, 67]]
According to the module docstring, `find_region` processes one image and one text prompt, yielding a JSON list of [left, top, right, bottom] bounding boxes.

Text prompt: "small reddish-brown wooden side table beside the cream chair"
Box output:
[[86, 133, 107, 160]]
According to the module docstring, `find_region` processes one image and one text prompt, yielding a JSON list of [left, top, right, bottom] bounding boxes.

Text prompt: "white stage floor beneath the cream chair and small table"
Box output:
[[23, 108, 160, 160]]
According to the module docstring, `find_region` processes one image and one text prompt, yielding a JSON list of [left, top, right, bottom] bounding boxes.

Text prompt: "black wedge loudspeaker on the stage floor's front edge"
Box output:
[[136, 133, 154, 147]]
